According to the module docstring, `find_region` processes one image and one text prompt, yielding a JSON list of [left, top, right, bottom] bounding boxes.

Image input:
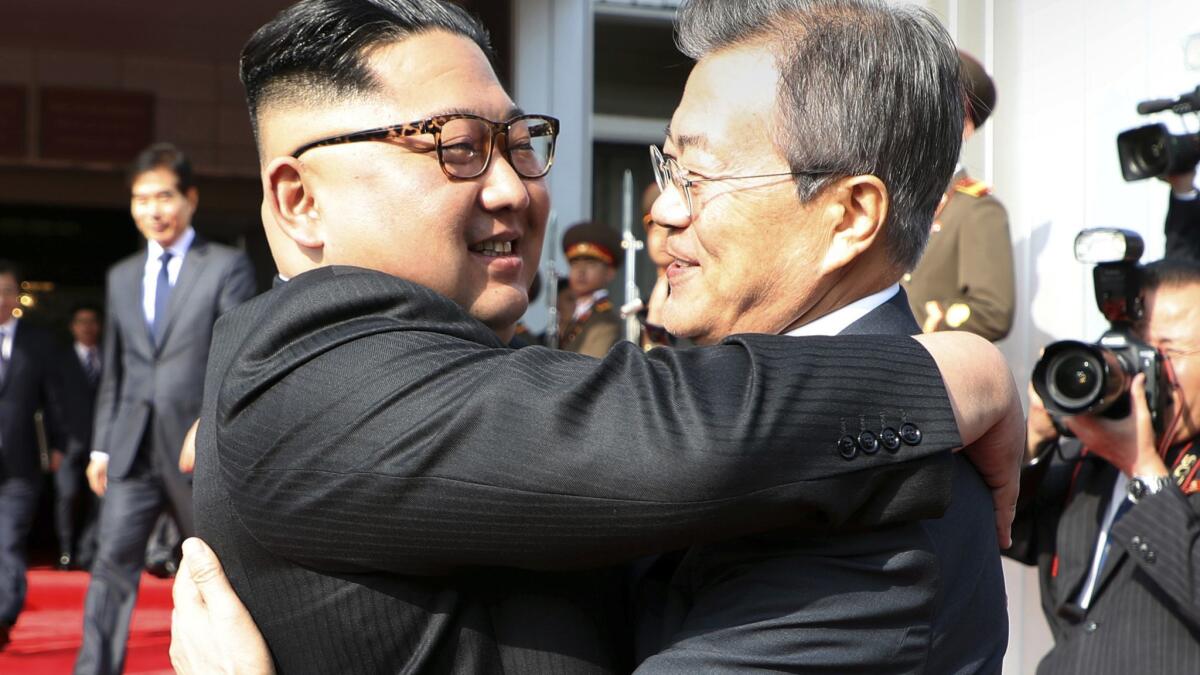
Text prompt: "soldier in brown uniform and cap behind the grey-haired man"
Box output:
[[904, 50, 1015, 341]]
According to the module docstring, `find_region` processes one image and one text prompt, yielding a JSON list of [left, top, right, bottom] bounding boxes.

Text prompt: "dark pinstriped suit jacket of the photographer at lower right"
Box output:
[[1006, 438, 1200, 675]]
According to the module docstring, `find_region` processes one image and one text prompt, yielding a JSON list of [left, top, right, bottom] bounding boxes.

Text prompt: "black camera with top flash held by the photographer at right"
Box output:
[[1033, 228, 1169, 431]]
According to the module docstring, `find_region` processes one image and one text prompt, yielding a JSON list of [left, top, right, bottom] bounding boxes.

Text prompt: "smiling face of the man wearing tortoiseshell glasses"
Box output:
[[259, 31, 548, 339]]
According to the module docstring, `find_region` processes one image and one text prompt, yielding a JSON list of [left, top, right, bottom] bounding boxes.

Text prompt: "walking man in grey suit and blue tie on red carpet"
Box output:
[[76, 144, 254, 673]]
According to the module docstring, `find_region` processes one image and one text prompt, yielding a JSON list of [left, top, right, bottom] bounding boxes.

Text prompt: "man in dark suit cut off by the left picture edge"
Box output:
[[0, 261, 64, 650]]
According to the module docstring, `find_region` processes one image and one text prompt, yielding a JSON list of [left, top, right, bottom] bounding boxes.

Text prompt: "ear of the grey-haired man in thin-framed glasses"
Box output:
[[823, 175, 889, 271]]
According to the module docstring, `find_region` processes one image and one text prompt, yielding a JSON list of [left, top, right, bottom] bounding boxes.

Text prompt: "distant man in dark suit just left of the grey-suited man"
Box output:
[[54, 305, 103, 569]]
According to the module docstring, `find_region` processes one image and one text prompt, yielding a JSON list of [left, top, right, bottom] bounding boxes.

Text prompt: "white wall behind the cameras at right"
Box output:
[[918, 0, 1200, 674]]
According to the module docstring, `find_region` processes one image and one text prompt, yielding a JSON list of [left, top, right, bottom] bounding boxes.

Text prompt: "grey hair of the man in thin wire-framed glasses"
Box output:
[[676, 0, 966, 270]]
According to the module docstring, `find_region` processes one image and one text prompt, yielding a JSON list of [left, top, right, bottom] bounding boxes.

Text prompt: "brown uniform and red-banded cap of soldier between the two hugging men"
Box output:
[[558, 222, 625, 358]]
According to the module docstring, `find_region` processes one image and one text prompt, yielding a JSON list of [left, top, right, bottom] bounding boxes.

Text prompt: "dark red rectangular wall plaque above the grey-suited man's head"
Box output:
[[40, 86, 154, 165]]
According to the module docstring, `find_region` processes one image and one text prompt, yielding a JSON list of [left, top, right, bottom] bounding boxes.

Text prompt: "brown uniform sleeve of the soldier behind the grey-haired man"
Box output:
[[942, 196, 1016, 341]]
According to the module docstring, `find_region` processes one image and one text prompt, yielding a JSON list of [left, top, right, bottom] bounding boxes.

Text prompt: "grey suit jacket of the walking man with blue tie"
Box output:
[[92, 235, 254, 478]]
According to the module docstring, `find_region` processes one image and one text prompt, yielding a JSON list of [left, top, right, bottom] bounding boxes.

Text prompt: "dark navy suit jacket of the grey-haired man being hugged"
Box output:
[[638, 291, 1008, 675]]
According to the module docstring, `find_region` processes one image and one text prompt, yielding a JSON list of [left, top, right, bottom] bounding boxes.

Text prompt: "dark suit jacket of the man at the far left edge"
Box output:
[[0, 321, 66, 479]]
